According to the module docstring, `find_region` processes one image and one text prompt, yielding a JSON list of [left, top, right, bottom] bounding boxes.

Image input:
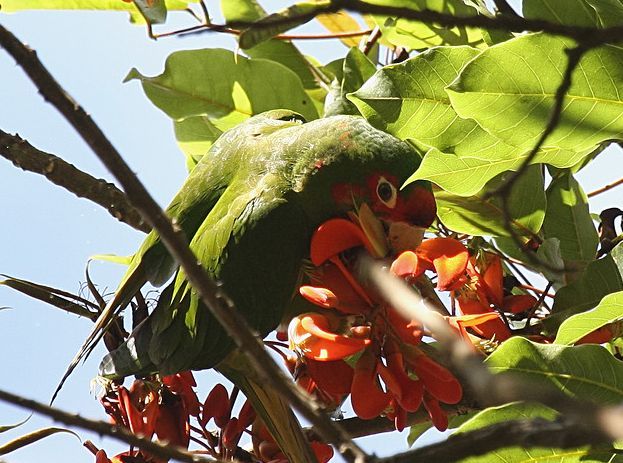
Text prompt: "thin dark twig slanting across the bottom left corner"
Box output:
[[0, 390, 222, 463]]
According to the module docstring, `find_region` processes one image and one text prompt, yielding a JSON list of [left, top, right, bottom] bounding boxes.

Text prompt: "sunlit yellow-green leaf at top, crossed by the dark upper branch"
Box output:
[[368, 0, 483, 50]]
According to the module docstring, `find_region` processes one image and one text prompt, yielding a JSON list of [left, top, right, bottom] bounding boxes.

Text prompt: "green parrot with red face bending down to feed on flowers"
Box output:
[[62, 110, 435, 463]]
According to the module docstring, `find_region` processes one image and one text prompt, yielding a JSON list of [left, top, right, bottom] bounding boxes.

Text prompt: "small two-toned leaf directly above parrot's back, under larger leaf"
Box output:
[[173, 116, 223, 172]]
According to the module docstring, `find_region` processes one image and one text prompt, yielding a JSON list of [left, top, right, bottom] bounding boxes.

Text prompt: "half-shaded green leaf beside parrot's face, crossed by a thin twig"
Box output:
[[435, 166, 546, 237]]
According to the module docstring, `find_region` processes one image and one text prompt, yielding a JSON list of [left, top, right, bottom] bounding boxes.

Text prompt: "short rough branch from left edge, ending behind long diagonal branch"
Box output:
[[0, 130, 150, 233]]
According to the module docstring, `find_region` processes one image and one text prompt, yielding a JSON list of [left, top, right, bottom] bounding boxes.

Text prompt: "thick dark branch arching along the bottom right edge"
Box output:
[[381, 418, 611, 463]]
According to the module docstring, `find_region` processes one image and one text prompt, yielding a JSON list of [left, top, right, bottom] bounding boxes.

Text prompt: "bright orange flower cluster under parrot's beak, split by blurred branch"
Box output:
[[288, 219, 536, 430]]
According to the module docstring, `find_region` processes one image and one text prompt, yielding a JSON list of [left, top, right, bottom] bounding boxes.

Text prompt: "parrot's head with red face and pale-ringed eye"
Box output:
[[286, 116, 436, 251]]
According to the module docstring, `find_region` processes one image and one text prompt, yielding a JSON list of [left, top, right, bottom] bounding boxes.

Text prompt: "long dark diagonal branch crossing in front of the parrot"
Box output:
[[0, 25, 369, 461]]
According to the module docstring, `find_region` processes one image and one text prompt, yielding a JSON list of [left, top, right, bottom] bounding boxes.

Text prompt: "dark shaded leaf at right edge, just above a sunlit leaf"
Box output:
[[543, 255, 623, 333]]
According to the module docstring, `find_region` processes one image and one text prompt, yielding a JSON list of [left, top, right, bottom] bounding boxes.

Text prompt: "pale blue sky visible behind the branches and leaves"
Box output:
[[0, 2, 621, 463]]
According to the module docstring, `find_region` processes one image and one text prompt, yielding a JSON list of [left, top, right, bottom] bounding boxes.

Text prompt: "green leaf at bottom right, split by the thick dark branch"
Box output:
[[455, 402, 613, 463]]
